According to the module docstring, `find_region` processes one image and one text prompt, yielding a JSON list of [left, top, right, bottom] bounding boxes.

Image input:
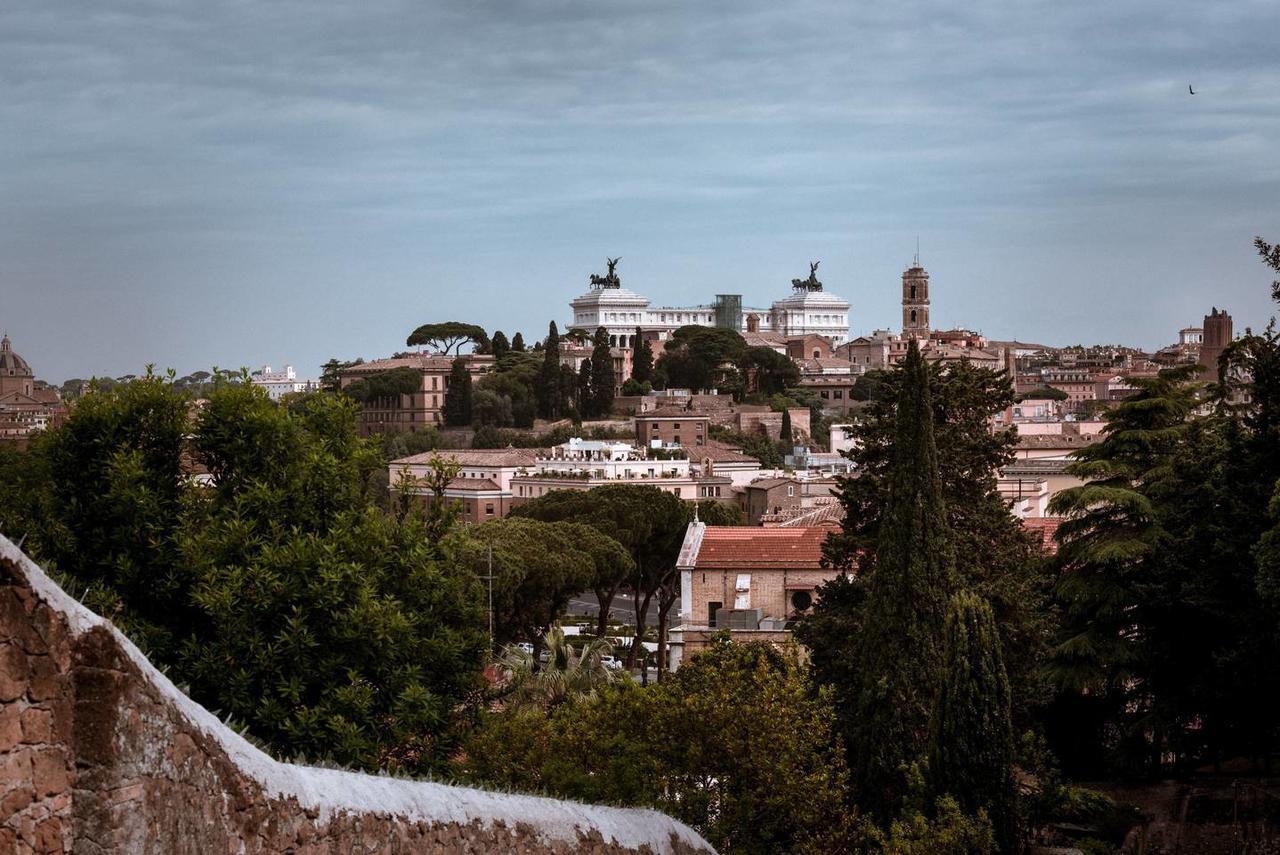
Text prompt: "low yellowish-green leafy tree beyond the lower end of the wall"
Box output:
[[462, 637, 847, 852]]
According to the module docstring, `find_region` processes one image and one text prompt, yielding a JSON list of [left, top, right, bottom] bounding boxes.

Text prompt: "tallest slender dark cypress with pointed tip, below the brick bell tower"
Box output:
[[850, 340, 955, 823]]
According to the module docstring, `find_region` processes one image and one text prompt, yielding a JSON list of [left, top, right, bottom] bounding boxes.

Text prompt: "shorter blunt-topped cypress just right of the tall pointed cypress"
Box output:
[[929, 591, 1019, 852]]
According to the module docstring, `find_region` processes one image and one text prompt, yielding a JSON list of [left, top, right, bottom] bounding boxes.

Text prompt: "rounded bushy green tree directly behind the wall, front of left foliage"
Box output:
[[179, 501, 484, 772]]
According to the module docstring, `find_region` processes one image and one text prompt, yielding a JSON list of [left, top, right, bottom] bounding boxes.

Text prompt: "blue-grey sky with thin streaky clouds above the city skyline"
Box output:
[[0, 0, 1280, 383]]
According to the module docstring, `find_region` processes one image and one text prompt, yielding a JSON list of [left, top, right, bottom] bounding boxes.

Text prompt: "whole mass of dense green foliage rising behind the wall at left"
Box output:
[[0, 374, 484, 772]]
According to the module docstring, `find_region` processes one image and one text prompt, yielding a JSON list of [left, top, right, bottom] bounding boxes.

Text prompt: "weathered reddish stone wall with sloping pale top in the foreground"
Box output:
[[0, 536, 712, 855]]
